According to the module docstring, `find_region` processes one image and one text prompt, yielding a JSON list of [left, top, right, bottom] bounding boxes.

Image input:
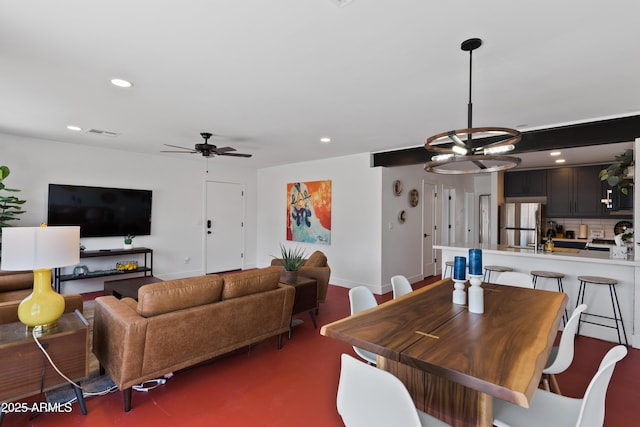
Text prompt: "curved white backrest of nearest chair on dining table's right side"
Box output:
[[576, 345, 627, 427]]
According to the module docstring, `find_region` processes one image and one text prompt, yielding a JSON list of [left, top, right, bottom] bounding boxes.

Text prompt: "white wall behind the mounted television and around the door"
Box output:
[[0, 134, 257, 293]]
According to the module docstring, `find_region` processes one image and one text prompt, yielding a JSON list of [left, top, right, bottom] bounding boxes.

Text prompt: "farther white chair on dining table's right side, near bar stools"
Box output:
[[542, 304, 587, 394]]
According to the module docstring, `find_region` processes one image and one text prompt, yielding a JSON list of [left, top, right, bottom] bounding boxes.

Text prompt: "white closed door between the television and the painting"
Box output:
[[204, 182, 244, 274]]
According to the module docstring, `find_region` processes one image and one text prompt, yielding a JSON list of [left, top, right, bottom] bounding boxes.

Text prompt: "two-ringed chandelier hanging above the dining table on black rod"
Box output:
[[424, 38, 522, 174]]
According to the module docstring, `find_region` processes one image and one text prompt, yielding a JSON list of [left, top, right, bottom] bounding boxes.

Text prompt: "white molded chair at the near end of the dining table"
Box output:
[[336, 354, 449, 427]]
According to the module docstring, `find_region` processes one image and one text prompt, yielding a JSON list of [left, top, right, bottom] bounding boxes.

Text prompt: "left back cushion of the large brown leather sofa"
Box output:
[[137, 274, 222, 317]]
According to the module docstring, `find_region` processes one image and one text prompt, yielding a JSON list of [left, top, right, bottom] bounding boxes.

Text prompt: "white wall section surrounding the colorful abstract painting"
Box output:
[[257, 153, 382, 293]]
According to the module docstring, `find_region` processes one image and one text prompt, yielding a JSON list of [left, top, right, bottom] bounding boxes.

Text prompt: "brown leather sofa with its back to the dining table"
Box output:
[[93, 267, 295, 412]]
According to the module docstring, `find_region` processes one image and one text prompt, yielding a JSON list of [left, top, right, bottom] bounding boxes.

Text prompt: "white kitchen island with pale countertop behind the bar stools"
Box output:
[[434, 243, 640, 348]]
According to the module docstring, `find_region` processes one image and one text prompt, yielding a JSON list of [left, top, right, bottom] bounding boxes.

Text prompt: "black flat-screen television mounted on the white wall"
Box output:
[[47, 184, 151, 237]]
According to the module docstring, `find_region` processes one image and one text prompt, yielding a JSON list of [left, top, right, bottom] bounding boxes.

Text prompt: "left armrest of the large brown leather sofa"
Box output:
[[93, 296, 148, 390]]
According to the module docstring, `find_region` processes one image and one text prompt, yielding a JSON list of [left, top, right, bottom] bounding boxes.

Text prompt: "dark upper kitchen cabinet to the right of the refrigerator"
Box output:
[[547, 166, 602, 218]]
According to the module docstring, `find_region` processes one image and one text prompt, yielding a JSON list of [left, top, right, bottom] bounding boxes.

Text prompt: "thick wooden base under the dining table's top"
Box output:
[[377, 356, 493, 427]]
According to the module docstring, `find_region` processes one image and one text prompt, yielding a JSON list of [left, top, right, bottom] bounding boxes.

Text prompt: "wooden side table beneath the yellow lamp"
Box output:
[[0, 310, 89, 422]]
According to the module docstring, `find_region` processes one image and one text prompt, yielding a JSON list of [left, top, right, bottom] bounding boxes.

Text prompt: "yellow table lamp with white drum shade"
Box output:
[[0, 225, 80, 330]]
